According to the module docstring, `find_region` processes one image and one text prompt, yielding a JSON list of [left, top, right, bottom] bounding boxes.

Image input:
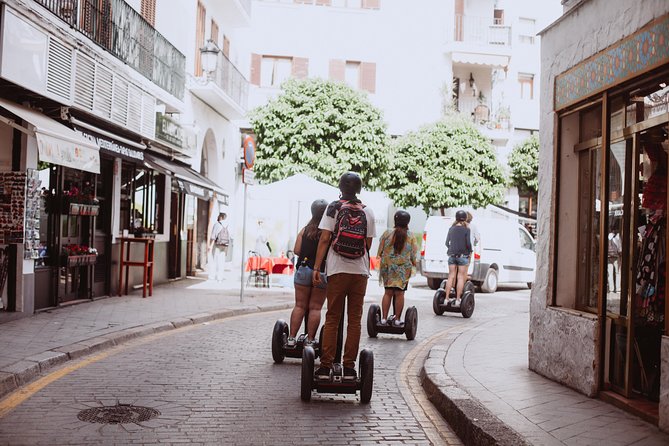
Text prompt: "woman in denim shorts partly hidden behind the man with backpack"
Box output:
[[287, 200, 328, 347]]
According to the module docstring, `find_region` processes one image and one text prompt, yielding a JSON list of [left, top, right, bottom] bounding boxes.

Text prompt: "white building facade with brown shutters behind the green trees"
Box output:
[[243, 0, 560, 213]]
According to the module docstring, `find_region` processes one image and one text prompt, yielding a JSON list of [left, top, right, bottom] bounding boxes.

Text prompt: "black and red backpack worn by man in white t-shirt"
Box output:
[[331, 200, 367, 259]]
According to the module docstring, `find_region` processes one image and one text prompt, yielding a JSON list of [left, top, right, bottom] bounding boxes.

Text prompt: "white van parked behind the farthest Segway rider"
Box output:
[[420, 216, 536, 293]]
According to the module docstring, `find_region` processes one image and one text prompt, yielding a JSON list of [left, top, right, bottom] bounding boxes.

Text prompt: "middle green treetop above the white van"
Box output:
[[384, 113, 505, 213]]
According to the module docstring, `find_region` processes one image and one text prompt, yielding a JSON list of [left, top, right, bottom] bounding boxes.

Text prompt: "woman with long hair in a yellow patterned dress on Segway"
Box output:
[[377, 210, 418, 327]]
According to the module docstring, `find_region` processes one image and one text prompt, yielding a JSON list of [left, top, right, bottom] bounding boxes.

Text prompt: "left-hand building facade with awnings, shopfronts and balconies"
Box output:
[[0, 0, 250, 315]]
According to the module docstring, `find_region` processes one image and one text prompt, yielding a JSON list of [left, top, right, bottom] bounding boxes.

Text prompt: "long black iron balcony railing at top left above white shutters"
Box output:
[[35, 0, 186, 99]]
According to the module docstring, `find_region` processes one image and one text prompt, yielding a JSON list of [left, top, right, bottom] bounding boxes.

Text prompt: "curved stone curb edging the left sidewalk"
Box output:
[[0, 302, 294, 399]]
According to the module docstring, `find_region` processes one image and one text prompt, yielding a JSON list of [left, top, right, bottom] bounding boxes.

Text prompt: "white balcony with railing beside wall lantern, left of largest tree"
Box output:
[[189, 52, 249, 119]]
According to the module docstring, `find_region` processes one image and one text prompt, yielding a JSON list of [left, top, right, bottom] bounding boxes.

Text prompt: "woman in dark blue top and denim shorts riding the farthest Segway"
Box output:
[[445, 210, 472, 306]]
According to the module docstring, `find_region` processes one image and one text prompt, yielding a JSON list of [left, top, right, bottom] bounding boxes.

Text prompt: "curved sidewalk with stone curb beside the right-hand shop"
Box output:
[[421, 313, 669, 446]]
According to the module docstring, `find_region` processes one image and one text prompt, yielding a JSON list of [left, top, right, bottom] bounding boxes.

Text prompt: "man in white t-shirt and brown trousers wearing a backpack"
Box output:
[[313, 172, 376, 381]]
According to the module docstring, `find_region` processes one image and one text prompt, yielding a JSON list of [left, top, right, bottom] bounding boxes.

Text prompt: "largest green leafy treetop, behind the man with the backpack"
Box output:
[[250, 79, 388, 190]]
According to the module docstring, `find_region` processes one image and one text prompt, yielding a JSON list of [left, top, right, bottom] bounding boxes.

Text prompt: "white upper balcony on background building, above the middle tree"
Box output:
[[446, 14, 511, 67]]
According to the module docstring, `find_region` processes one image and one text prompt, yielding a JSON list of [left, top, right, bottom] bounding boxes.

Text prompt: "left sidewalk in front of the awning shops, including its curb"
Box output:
[[0, 268, 294, 398]]
